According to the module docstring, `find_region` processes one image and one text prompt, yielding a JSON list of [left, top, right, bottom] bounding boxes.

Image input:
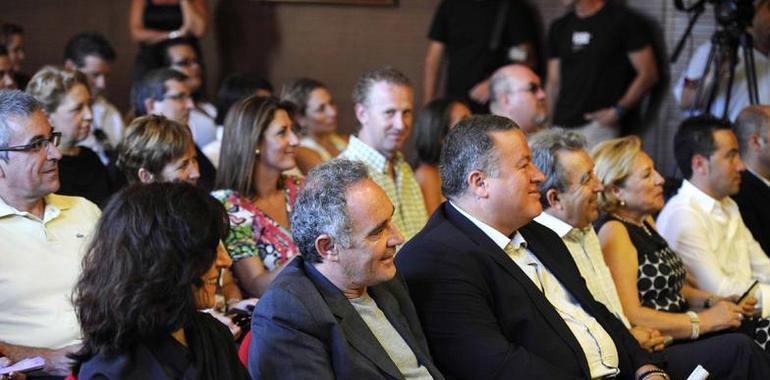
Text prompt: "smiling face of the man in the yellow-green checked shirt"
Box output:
[[355, 82, 413, 158]]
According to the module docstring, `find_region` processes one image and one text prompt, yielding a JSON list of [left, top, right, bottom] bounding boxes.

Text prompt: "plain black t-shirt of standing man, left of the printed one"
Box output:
[[428, 0, 535, 107]]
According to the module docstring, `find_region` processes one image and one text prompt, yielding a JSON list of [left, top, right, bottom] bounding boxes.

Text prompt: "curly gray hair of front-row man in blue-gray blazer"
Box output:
[[291, 159, 369, 263]]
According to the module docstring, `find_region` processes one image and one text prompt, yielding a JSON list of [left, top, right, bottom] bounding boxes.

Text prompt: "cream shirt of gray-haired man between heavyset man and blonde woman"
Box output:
[[535, 212, 631, 329]]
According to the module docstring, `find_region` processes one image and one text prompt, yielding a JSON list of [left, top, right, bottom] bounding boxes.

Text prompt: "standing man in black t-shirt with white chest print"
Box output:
[[546, 0, 658, 146]]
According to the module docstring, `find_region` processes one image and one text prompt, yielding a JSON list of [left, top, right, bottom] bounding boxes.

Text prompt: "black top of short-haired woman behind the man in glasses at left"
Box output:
[[56, 147, 112, 207]]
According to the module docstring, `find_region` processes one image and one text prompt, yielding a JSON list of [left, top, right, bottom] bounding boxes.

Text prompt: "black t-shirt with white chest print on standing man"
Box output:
[[548, 3, 651, 127]]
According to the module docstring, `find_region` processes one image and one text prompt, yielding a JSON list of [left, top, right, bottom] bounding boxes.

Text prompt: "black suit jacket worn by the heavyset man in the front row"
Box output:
[[396, 202, 652, 379]]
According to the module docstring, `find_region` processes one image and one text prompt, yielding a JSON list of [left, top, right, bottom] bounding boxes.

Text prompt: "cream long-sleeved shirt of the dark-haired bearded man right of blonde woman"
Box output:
[[657, 180, 770, 318]]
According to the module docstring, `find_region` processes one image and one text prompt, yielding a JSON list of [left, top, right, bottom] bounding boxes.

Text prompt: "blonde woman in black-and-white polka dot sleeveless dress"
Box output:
[[592, 136, 766, 350]]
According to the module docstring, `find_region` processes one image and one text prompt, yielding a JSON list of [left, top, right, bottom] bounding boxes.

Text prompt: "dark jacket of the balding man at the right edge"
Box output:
[[733, 170, 770, 256]]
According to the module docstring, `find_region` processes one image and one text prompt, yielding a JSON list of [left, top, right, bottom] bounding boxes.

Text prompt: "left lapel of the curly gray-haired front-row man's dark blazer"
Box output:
[[305, 263, 403, 379]]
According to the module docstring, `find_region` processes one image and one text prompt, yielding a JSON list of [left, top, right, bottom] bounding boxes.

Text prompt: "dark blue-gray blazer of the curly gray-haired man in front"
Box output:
[[249, 257, 444, 380]]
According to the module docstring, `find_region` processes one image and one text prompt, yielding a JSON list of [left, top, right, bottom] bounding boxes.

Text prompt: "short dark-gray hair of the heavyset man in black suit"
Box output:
[[439, 115, 519, 199]]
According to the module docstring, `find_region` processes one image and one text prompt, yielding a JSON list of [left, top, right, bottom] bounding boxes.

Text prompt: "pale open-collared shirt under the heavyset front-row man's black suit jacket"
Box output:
[[449, 201, 620, 379]]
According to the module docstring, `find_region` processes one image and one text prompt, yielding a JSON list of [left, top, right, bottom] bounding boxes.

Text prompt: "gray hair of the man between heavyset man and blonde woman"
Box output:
[[529, 128, 586, 209]]
